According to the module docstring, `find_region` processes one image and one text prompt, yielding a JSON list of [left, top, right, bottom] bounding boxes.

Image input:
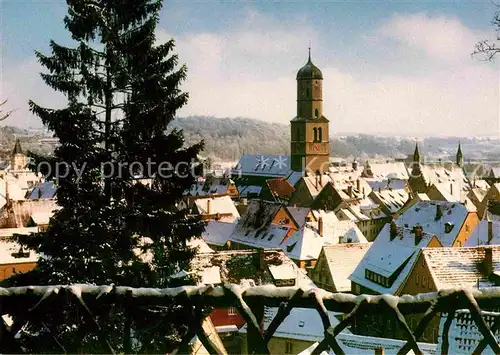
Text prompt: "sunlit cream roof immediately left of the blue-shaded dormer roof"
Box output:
[[316, 243, 372, 292]]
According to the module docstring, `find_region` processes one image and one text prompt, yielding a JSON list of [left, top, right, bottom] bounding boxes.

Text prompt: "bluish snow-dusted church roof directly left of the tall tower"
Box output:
[[232, 154, 292, 177]]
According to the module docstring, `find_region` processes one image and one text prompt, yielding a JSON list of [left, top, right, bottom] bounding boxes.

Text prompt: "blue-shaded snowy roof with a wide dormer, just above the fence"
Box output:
[[349, 223, 434, 294]]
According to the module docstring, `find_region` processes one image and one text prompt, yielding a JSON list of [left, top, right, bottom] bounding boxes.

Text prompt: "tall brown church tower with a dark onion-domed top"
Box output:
[[290, 48, 330, 174]]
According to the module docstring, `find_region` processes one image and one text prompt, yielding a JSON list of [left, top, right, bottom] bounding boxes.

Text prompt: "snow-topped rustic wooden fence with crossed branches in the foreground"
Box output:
[[0, 284, 500, 354]]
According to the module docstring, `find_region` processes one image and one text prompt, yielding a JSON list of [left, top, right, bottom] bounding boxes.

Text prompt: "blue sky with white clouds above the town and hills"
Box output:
[[0, 0, 499, 136]]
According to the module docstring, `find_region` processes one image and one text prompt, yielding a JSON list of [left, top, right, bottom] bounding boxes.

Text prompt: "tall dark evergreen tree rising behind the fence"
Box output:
[[4, 0, 204, 352]]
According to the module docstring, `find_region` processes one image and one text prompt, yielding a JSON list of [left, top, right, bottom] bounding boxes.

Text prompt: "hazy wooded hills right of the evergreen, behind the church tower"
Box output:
[[174, 116, 500, 161]]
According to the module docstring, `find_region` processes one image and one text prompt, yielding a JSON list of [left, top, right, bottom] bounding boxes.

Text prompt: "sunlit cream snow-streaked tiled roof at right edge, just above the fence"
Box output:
[[422, 245, 500, 290]]
